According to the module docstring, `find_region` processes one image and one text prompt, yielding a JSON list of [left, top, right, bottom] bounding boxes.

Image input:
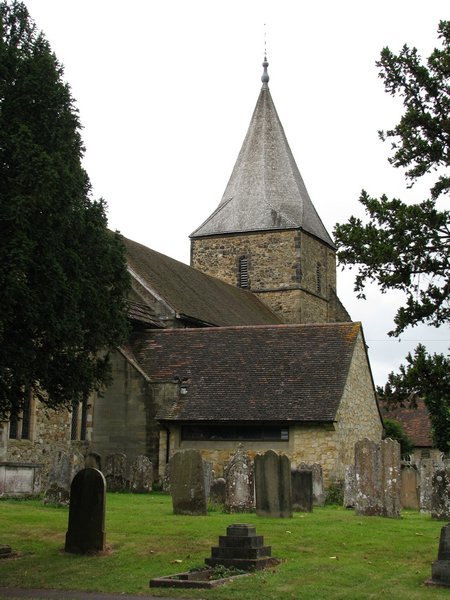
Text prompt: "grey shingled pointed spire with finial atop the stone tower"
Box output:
[[190, 57, 334, 248]]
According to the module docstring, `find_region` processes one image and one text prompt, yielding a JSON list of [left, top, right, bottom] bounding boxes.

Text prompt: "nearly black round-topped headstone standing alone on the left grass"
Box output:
[[64, 467, 106, 554]]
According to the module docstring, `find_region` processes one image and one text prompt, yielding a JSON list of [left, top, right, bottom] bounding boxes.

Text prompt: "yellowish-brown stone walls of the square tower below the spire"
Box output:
[[191, 229, 342, 323]]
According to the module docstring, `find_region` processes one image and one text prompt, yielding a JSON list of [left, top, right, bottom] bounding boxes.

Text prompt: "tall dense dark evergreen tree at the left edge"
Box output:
[[0, 1, 129, 417]]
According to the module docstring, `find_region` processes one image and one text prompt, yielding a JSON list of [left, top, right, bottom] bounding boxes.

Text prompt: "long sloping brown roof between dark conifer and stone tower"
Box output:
[[122, 237, 280, 326]]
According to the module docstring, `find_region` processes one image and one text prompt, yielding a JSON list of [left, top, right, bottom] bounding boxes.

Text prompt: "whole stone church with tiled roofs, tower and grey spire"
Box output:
[[0, 59, 383, 495]]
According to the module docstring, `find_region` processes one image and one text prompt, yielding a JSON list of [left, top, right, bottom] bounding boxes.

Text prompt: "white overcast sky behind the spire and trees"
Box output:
[[26, 0, 450, 384]]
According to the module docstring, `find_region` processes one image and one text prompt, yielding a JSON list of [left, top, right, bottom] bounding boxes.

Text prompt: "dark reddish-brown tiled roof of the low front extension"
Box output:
[[133, 323, 361, 422]]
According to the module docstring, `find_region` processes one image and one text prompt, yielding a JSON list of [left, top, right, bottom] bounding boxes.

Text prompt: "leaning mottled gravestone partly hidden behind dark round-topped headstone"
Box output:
[[43, 452, 84, 506]]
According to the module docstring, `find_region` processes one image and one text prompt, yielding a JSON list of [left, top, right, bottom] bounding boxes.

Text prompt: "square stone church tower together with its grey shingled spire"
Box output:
[[190, 58, 350, 323]]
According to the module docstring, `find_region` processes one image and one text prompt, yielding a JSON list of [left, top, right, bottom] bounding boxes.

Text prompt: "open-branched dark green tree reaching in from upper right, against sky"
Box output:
[[334, 21, 450, 335]]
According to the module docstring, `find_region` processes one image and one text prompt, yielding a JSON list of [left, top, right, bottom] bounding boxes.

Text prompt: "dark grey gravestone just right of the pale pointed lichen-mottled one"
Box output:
[[255, 450, 292, 517]]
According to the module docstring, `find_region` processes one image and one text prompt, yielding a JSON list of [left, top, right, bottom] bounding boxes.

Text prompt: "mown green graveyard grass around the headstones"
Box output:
[[0, 493, 449, 600]]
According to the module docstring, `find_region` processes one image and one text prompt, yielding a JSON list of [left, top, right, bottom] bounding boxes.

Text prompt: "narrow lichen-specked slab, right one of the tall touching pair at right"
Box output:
[[380, 438, 401, 519]]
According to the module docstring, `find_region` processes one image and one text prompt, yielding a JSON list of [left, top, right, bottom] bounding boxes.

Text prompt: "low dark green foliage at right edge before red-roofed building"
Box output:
[[377, 344, 450, 453]]
